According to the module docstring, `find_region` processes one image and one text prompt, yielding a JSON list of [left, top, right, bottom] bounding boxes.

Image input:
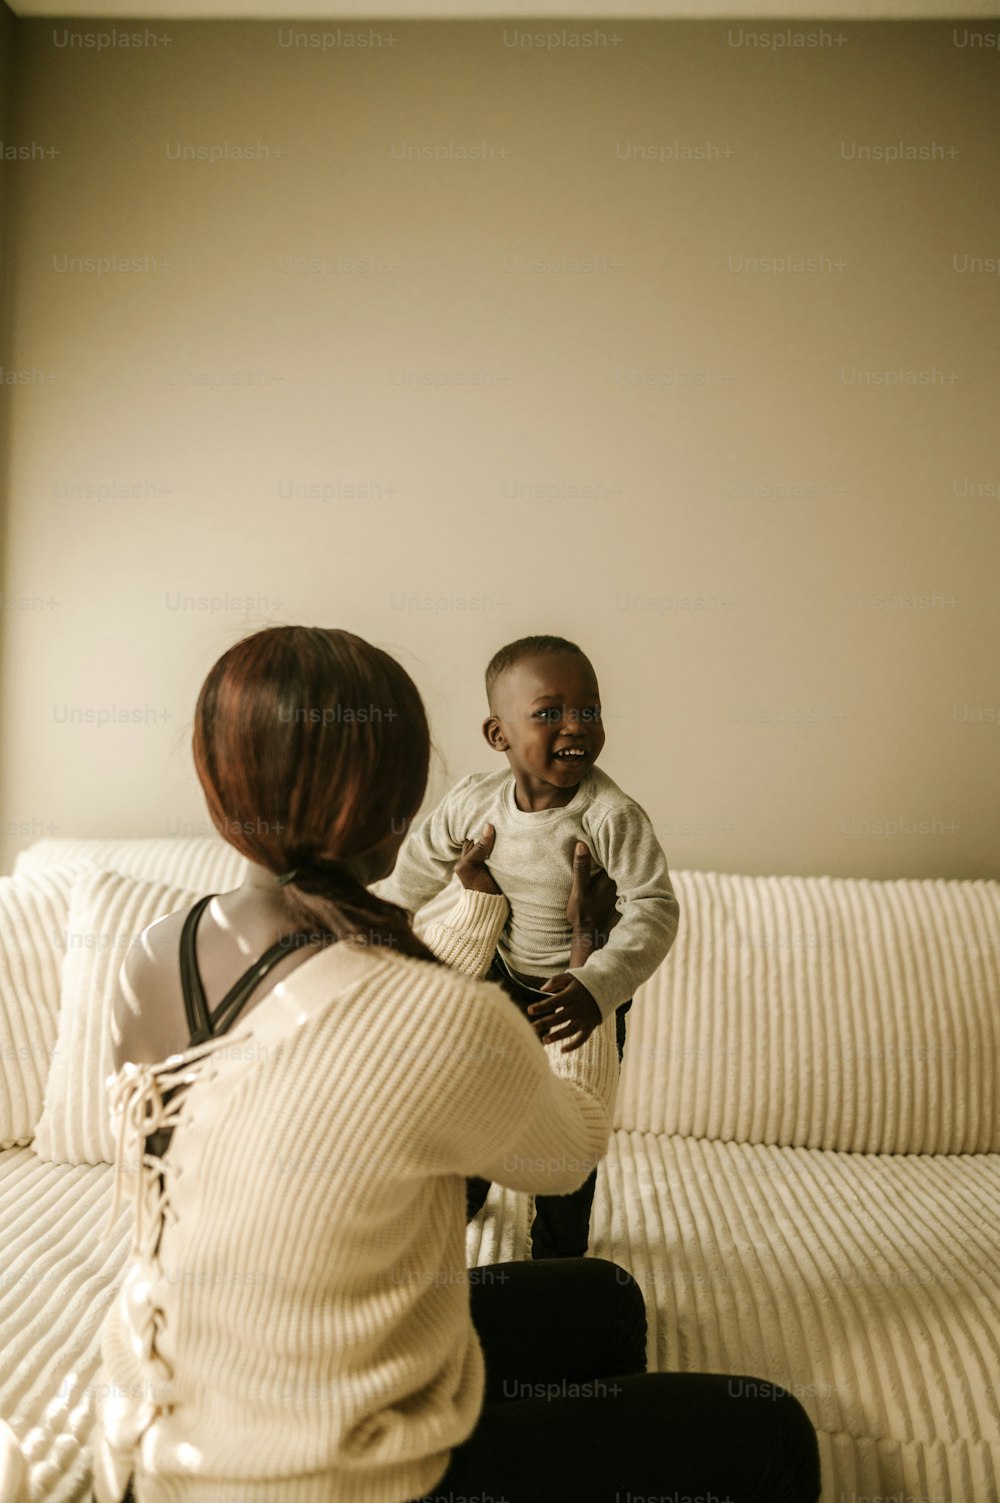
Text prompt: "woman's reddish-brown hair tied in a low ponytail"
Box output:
[[192, 627, 436, 960]]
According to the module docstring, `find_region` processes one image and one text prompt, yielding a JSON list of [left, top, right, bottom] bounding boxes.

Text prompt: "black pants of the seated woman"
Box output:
[[412, 1258, 820, 1503]]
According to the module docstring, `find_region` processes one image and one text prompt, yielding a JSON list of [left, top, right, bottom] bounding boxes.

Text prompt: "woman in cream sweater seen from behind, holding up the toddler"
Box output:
[[95, 627, 820, 1503]]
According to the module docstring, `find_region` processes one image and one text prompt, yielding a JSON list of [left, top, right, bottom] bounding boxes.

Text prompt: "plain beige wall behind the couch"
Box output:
[[0, 21, 1000, 876]]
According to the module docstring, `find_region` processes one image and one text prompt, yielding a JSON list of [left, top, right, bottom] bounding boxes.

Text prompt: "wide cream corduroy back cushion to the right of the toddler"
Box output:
[[617, 872, 1000, 1153]]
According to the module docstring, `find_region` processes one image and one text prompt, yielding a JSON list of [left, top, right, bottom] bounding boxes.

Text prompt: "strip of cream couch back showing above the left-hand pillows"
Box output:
[[14, 836, 245, 893]]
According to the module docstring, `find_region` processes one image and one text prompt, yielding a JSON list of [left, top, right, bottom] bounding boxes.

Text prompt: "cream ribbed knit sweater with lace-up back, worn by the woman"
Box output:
[[95, 891, 618, 1503]]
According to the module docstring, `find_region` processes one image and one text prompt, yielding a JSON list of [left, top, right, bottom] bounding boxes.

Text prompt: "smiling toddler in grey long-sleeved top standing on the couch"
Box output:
[[376, 636, 678, 1258]]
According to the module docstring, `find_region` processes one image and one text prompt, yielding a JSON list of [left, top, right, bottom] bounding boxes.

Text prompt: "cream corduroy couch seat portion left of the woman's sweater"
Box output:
[[0, 1148, 132, 1503]]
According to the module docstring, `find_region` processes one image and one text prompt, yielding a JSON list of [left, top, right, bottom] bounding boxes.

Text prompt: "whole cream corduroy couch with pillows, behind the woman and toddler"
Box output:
[[0, 837, 1000, 1503]]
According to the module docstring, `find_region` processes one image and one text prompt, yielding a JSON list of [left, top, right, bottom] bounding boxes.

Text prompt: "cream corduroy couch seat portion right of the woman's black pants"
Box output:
[[589, 1132, 1000, 1503]]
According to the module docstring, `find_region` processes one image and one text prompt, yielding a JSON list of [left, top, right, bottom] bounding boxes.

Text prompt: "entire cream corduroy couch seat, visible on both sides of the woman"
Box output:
[[0, 1132, 1000, 1503]]
